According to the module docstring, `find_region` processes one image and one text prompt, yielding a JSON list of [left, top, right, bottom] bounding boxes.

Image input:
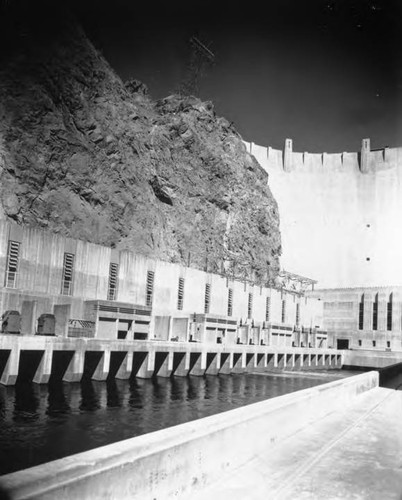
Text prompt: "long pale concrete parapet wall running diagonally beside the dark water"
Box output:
[[0, 372, 378, 500]]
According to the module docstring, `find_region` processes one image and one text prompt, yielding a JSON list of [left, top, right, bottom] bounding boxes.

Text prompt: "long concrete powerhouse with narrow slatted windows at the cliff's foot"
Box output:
[[0, 220, 326, 348]]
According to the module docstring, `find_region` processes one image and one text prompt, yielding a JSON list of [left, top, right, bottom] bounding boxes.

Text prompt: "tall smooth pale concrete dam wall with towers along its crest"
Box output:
[[245, 139, 402, 287]]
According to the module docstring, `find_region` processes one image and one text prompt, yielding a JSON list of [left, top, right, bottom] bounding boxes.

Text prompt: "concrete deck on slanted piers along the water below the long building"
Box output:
[[0, 334, 342, 385]]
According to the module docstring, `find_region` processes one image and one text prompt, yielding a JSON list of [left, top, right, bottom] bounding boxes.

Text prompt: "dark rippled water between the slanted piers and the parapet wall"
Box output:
[[0, 372, 347, 474]]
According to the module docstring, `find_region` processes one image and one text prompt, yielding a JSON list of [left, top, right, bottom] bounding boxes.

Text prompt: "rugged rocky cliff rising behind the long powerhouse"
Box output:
[[0, 5, 281, 281]]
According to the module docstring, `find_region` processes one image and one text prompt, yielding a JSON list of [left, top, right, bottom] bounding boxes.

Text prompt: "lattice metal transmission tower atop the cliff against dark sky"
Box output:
[[179, 36, 215, 96]]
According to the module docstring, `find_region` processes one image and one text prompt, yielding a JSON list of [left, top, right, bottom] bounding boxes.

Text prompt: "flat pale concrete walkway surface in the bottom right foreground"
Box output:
[[189, 388, 402, 500]]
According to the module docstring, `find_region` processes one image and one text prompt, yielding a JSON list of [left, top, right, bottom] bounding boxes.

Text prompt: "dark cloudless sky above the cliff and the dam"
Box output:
[[16, 0, 402, 152]]
